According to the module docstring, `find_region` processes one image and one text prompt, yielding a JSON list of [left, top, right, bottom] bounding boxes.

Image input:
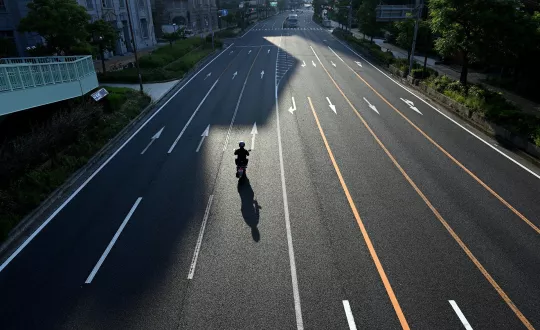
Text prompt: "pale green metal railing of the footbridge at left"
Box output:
[[0, 55, 95, 93]]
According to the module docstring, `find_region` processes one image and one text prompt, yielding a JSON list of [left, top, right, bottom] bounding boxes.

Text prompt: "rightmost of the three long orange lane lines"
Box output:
[[324, 44, 540, 234]]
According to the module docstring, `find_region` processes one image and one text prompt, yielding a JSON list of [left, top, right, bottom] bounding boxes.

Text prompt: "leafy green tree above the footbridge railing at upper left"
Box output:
[[19, 0, 90, 55]]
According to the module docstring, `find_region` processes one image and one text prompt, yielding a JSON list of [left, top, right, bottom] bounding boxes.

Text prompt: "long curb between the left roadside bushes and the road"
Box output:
[[0, 45, 227, 264]]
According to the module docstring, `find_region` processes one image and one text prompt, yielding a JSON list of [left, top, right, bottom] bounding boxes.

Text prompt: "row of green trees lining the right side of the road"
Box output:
[[313, 0, 540, 89]]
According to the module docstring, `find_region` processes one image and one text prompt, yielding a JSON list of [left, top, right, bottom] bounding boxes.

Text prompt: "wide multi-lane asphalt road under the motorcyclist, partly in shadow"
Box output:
[[0, 11, 540, 329]]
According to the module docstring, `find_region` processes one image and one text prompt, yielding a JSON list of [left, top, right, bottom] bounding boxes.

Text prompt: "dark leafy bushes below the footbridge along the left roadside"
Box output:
[[0, 87, 150, 241]]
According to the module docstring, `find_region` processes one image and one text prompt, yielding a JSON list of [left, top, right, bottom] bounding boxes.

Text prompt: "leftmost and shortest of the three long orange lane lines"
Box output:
[[308, 96, 410, 329]]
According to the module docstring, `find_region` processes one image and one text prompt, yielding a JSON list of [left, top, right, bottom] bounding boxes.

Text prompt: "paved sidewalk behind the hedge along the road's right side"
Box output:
[[332, 21, 540, 116]]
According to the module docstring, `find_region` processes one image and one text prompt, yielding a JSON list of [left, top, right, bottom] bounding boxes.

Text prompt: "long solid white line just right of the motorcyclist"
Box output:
[[275, 35, 304, 330]]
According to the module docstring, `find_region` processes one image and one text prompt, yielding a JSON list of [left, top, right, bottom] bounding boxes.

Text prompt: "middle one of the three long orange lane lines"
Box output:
[[313, 51, 534, 330]]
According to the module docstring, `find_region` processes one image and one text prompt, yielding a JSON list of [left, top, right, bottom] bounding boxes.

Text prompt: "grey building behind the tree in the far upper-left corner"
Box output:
[[0, 0, 157, 56]]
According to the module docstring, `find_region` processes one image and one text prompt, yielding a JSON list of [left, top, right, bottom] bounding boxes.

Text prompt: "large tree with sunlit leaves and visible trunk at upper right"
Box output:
[[429, 0, 519, 85]]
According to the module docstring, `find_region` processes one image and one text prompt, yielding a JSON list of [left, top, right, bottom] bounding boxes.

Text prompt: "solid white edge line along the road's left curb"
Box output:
[[0, 43, 234, 272]]
